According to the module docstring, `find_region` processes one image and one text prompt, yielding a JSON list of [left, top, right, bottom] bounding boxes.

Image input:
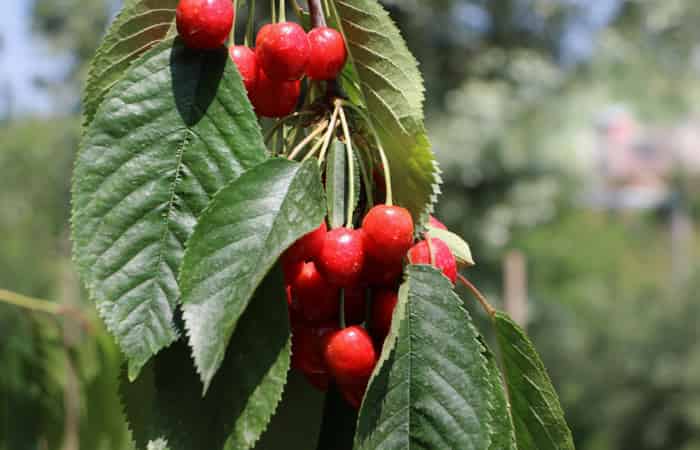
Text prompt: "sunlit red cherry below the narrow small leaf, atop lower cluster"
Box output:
[[317, 228, 365, 287]]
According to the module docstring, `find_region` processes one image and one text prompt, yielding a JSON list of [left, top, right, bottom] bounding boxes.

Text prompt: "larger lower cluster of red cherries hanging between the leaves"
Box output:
[[282, 205, 457, 408]]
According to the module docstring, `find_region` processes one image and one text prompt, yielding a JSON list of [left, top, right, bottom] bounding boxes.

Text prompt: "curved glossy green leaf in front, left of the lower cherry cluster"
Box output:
[[180, 159, 326, 391]]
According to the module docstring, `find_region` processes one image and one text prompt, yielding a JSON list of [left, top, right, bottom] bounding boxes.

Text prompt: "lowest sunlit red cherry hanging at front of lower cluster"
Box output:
[[324, 325, 377, 385]]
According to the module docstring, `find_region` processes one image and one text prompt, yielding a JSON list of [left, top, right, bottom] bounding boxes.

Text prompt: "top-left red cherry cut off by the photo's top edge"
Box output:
[[175, 0, 235, 50]]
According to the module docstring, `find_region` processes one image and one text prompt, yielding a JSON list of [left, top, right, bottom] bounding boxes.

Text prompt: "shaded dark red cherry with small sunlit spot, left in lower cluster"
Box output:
[[291, 262, 340, 322]]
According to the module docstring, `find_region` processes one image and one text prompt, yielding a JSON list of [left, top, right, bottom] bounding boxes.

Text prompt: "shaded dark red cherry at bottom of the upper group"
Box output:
[[248, 69, 301, 117]]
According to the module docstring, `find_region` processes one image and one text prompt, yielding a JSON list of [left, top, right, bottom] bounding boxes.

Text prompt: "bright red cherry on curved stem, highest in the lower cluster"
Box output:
[[362, 205, 413, 263]]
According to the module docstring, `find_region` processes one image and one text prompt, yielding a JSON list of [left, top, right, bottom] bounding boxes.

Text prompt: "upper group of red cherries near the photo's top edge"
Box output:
[[176, 0, 347, 117]]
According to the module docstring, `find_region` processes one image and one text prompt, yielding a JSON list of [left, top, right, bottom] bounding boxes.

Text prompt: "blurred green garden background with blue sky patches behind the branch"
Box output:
[[0, 0, 700, 450]]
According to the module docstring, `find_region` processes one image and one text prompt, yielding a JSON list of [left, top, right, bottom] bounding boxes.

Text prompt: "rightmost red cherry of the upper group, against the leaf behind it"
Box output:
[[306, 27, 348, 80]]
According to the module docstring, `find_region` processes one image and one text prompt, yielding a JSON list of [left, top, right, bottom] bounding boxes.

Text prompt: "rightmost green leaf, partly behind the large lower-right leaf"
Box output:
[[493, 312, 574, 450]]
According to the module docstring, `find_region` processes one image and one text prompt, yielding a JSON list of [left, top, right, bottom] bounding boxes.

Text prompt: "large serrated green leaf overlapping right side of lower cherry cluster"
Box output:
[[355, 266, 493, 450]]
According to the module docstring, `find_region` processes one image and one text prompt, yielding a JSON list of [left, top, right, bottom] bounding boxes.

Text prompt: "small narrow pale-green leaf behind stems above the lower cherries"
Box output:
[[326, 140, 348, 228]]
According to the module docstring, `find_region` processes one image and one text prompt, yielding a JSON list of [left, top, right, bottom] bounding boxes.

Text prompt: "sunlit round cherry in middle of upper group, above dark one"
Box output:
[[255, 22, 309, 81]]
